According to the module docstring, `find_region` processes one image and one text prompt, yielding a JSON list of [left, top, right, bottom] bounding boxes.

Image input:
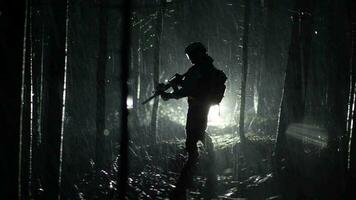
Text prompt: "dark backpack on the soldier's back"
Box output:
[[208, 67, 227, 105]]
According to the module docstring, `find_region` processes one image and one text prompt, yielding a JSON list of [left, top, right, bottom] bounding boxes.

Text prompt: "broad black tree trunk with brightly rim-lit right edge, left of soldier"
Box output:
[[43, 1, 67, 199]]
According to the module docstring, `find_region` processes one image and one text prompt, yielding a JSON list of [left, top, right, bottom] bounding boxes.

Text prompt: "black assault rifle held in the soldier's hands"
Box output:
[[142, 74, 185, 105]]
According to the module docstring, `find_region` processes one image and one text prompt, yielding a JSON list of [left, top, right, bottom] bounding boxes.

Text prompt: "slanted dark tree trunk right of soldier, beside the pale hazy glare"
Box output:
[[274, 0, 313, 198]]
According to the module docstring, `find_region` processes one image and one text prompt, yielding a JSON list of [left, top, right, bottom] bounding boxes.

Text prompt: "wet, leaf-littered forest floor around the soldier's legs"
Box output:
[[68, 121, 342, 200]]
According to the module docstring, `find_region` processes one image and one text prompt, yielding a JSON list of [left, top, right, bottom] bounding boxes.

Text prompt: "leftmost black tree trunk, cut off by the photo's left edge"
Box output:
[[0, 1, 27, 200]]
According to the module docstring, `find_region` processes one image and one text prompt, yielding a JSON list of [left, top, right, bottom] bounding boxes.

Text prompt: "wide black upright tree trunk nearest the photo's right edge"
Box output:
[[320, 0, 350, 198]]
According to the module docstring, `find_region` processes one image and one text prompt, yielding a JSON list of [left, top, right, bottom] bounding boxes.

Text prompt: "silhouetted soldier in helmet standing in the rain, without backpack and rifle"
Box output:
[[161, 42, 216, 199]]
